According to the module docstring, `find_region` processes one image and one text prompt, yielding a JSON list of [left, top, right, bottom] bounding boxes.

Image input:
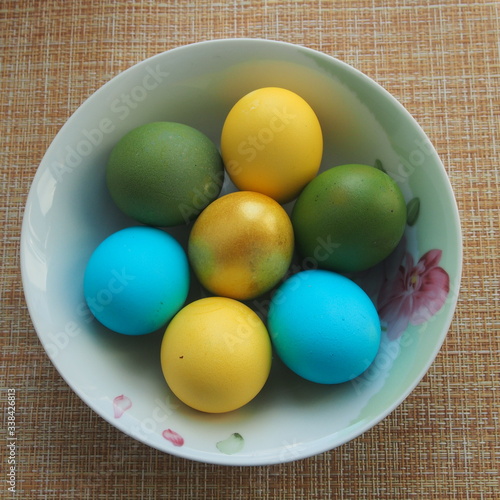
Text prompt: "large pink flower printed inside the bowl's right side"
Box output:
[[378, 250, 450, 340]]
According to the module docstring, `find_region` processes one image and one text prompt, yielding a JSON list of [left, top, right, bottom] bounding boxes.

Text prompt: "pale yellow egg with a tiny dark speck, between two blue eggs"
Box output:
[[161, 297, 271, 413]]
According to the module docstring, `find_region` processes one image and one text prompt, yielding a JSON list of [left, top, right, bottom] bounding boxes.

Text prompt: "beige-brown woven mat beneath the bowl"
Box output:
[[0, 0, 500, 499]]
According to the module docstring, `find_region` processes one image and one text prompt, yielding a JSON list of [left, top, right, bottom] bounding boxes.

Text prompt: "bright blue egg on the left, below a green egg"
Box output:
[[83, 226, 189, 335]]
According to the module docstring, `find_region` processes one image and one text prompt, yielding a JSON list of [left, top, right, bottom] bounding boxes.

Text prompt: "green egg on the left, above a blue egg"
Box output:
[[106, 122, 224, 227]]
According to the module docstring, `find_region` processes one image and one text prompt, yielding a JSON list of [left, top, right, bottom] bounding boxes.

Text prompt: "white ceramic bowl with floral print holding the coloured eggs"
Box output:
[[21, 39, 462, 465]]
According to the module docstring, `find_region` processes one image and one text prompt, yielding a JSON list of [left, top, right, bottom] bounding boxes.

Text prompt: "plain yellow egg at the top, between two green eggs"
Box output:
[[221, 87, 323, 203]]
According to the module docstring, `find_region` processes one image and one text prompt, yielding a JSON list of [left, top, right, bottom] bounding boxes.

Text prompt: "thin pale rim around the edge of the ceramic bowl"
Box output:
[[20, 37, 463, 466]]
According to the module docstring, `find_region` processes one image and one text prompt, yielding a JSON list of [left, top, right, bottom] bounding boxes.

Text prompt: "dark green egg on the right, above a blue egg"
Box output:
[[292, 164, 406, 273]]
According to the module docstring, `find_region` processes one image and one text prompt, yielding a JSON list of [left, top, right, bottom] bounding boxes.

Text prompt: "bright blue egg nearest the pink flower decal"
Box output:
[[268, 270, 381, 384]]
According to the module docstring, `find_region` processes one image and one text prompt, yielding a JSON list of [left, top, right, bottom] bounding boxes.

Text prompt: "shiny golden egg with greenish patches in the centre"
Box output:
[[188, 191, 294, 300]]
